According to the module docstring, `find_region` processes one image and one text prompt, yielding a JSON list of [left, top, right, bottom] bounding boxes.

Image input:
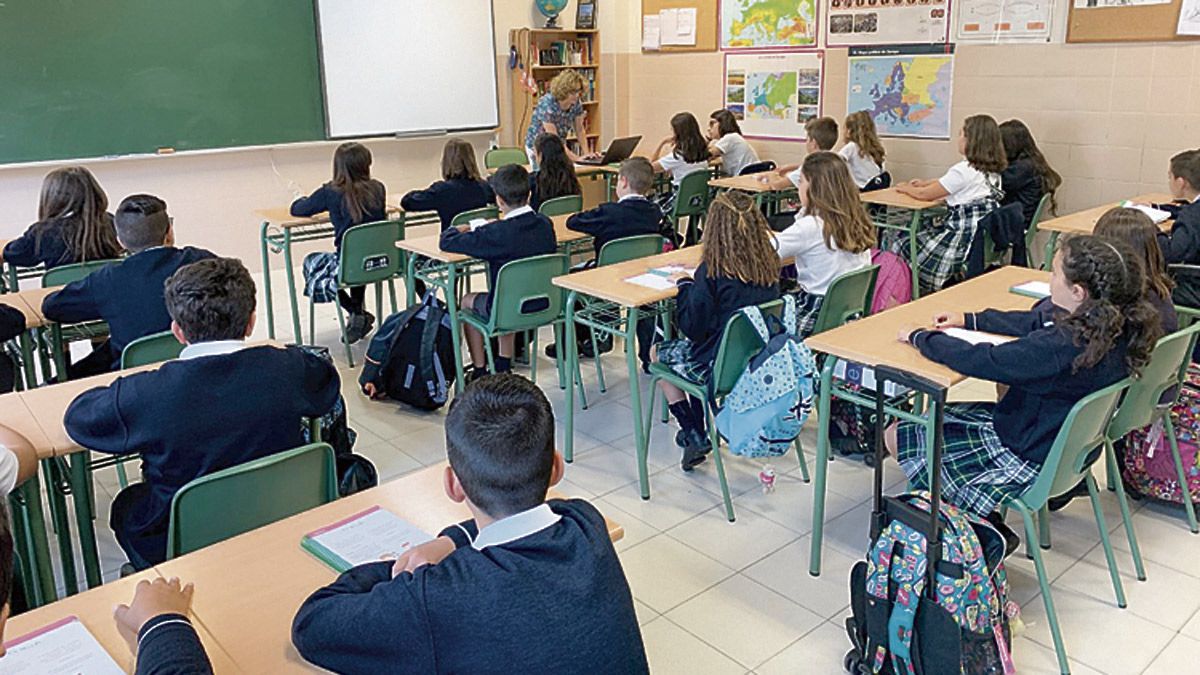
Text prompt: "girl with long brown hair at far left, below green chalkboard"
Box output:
[[4, 167, 121, 269]]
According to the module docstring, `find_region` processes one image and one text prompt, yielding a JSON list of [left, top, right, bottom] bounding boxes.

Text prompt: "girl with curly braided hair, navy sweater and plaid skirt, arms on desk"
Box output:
[[884, 235, 1162, 525]]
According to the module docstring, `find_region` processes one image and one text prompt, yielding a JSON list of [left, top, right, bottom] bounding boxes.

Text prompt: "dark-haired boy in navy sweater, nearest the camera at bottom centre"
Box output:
[[292, 375, 648, 674]]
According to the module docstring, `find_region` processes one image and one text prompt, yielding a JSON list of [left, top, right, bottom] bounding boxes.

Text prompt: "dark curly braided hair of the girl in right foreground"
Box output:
[[1060, 235, 1162, 375]]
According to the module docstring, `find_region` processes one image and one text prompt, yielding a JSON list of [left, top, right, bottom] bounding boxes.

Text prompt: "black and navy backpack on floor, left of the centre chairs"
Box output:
[[359, 293, 458, 410]]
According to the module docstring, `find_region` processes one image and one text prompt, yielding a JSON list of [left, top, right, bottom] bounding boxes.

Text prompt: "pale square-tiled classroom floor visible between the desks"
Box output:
[[56, 270, 1200, 675]]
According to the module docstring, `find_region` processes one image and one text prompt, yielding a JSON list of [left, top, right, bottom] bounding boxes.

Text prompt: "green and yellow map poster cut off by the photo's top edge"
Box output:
[[721, 0, 817, 49]]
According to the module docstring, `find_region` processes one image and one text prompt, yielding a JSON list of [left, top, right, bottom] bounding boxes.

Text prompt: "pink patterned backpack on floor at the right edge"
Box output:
[[1121, 364, 1200, 504]]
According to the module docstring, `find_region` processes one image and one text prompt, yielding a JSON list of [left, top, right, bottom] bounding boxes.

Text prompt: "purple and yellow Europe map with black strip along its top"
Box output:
[[846, 44, 954, 138]]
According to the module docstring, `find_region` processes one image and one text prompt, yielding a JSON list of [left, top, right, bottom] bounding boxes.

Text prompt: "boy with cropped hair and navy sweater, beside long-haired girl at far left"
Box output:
[[42, 195, 214, 380]]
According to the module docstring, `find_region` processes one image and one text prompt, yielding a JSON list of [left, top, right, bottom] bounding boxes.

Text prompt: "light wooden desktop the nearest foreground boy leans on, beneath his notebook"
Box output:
[[157, 464, 624, 674]]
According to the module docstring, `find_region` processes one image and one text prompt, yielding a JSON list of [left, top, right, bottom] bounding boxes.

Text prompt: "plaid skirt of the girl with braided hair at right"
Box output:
[[896, 404, 1042, 516]]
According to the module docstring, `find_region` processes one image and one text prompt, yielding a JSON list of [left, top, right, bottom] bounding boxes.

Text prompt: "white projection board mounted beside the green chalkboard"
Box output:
[[317, 0, 499, 138]]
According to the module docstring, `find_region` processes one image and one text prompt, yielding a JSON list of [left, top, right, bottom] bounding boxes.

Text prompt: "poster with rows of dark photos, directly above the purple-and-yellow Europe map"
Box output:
[[826, 0, 950, 47]]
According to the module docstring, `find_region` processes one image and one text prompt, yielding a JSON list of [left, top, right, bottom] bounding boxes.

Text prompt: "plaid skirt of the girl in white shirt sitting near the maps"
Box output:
[[892, 197, 997, 294]]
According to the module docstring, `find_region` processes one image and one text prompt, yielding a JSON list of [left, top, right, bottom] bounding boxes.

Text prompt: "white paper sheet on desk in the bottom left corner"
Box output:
[[0, 616, 125, 675]]
